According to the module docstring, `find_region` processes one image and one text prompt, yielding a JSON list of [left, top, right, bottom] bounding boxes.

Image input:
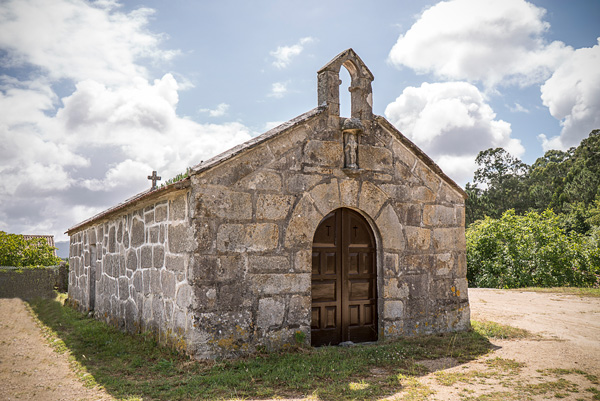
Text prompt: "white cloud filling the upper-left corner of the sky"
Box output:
[[0, 0, 178, 83]]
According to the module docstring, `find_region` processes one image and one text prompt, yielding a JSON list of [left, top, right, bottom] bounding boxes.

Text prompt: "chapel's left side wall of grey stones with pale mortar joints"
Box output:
[[69, 190, 194, 349]]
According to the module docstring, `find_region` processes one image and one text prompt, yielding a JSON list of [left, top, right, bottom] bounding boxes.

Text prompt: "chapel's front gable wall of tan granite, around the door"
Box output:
[[185, 113, 469, 358]]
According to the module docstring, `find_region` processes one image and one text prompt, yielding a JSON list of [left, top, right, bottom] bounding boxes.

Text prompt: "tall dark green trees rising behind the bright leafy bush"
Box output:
[[465, 130, 600, 228]]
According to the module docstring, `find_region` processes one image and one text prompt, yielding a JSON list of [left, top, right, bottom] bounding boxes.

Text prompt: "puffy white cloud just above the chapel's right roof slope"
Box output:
[[385, 82, 524, 184]]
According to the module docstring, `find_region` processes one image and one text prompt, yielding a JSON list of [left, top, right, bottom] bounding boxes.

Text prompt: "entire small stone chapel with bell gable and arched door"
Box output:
[[67, 49, 470, 358]]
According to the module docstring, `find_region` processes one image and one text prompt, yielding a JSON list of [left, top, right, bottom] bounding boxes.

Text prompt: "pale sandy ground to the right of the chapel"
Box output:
[[418, 289, 600, 401]]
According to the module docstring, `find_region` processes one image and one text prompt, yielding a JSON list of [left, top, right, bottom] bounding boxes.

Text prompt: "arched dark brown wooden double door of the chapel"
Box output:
[[311, 209, 377, 346]]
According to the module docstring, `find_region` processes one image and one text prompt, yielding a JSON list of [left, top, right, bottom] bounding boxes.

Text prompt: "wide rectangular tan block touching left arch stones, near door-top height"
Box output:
[[216, 223, 279, 252]]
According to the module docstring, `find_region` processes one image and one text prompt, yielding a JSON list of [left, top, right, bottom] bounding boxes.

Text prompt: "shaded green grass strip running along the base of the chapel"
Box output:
[[25, 299, 491, 400]]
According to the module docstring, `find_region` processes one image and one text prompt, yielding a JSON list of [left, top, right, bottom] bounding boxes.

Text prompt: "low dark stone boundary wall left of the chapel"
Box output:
[[0, 264, 68, 299]]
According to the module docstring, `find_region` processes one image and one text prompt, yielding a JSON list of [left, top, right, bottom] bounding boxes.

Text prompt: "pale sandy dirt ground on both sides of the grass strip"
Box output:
[[0, 289, 600, 401]]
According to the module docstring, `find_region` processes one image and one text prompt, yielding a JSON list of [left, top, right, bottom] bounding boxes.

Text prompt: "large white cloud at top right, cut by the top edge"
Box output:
[[389, 0, 573, 87]]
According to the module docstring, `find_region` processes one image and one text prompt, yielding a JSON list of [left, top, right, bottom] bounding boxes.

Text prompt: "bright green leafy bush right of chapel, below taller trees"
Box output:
[[467, 209, 600, 288]]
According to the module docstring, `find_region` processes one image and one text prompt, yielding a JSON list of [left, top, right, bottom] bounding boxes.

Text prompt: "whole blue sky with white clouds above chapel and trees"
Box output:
[[0, 0, 600, 240]]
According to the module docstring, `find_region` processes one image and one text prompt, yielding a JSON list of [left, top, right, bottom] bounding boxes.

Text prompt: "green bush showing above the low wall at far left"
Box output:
[[0, 231, 61, 267]]
